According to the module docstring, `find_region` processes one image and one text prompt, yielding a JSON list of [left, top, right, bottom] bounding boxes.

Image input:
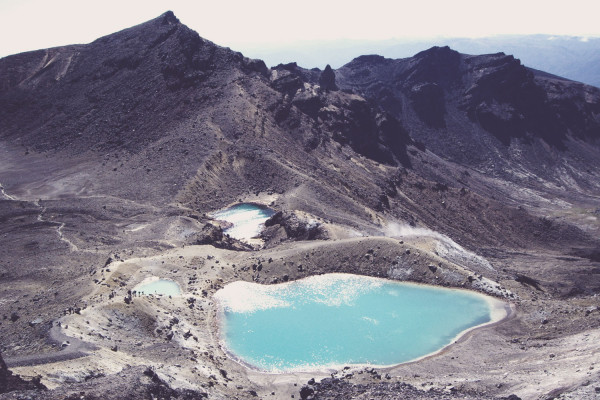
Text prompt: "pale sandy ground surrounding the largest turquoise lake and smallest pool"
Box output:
[[13, 227, 600, 399]]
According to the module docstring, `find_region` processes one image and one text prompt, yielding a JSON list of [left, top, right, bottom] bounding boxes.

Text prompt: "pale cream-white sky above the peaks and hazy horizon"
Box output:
[[0, 0, 600, 57]]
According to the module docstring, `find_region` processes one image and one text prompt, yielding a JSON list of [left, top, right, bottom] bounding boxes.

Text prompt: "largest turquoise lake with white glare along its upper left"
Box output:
[[215, 274, 506, 372]]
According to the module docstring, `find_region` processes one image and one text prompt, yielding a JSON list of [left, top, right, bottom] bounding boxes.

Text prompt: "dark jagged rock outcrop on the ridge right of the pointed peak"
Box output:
[[271, 63, 412, 165]]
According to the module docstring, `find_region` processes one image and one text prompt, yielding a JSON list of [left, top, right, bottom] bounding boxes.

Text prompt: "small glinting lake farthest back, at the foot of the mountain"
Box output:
[[212, 203, 275, 240]]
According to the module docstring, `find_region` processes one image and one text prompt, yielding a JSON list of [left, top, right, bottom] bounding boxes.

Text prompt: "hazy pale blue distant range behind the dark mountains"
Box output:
[[234, 35, 600, 87]]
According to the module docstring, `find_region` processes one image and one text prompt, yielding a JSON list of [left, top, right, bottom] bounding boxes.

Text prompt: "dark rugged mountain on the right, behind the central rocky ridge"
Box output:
[[336, 47, 600, 180]]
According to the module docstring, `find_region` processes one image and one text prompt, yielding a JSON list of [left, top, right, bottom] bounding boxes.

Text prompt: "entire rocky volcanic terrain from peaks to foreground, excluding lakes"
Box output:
[[0, 12, 600, 400]]
